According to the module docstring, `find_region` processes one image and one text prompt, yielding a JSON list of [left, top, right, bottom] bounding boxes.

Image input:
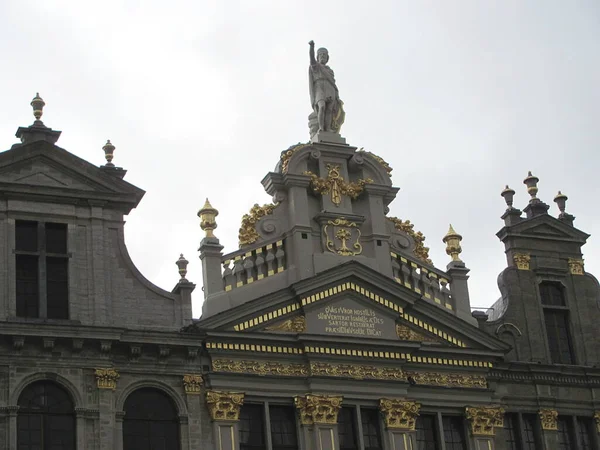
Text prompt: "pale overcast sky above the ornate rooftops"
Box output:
[[0, 0, 600, 317]]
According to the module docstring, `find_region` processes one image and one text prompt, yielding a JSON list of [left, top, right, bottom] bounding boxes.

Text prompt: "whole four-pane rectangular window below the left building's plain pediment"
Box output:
[[15, 220, 69, 319]]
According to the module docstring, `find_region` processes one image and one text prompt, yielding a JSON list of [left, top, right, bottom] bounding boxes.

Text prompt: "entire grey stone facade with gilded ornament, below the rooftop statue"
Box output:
[[0, 96, 600, 450]]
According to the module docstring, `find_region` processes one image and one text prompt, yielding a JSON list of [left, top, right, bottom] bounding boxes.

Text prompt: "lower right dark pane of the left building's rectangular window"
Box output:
[[46, 258, 69, 319]]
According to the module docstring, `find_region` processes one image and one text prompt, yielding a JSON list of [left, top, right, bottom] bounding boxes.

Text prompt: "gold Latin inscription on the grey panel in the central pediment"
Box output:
[[317, 306, 384, 337]]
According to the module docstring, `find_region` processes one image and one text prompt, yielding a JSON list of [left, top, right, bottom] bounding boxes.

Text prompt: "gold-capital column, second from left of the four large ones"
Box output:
[[294, 394, 342, 450]]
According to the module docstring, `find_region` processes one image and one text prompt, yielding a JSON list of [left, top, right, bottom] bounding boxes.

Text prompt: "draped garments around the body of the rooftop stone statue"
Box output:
[[308, 62, 345, 133]]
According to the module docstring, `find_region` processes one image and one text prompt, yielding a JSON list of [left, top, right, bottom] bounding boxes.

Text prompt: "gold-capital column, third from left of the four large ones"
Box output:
[[379, 398, 421, 450]]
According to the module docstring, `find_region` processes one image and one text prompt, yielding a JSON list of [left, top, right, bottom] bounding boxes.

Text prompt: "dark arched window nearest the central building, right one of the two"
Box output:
[[123, 388, 180, 450]]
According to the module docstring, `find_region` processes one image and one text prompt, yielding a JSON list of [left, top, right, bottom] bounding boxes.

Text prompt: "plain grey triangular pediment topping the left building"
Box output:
[[0, 141, 144, 207]]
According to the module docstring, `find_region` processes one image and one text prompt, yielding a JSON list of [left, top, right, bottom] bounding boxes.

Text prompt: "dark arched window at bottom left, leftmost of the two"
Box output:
[[17, 381, 75, 450]]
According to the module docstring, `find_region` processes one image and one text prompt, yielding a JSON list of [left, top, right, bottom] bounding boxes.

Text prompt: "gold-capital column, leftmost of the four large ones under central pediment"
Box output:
[[206, 391, 244, 450]]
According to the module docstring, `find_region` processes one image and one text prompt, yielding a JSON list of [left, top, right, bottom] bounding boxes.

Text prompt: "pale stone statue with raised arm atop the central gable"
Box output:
[[308, 41, 345, 138]]
